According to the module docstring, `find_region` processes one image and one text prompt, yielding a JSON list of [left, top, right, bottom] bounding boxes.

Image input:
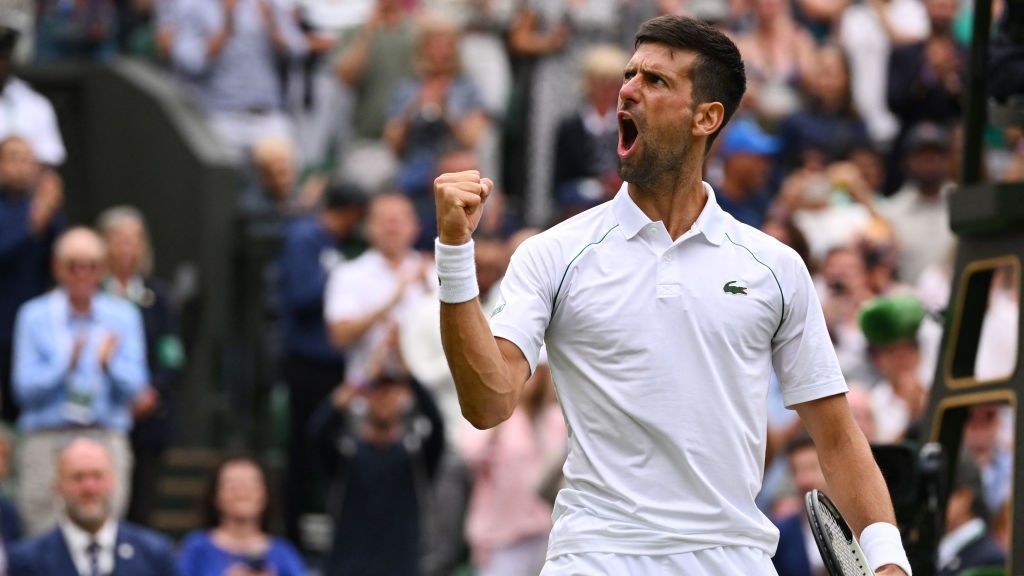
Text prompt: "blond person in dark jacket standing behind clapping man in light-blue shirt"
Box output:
[[96, 206, 185, 525]]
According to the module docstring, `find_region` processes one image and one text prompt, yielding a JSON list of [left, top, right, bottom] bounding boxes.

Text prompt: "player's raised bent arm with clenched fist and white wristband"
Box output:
[[434, 170, 530, 429]]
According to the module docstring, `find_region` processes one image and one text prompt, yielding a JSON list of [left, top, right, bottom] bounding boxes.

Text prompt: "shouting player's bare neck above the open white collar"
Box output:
[[629, 167, 708, 240]]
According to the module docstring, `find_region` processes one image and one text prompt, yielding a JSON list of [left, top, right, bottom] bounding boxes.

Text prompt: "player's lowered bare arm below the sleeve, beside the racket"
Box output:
[[795, 394, 905, 576]]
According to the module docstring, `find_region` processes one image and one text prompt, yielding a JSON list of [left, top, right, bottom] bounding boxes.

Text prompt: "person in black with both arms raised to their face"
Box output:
[[310, 331, 444, 576]]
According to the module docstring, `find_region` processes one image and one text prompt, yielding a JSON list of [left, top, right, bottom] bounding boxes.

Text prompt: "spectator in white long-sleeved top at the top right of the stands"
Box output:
[[839, 0, 928, 149]]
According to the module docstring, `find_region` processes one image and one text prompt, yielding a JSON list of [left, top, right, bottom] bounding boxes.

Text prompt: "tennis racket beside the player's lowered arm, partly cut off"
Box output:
[[804, 490, 872, 576]]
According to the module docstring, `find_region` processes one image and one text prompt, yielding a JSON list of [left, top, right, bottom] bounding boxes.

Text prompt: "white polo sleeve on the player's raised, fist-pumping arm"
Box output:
[[490, 236, 557, 374]]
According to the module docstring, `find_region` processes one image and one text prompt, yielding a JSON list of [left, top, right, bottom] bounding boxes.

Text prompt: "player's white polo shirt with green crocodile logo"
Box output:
[[490, 183, 847, 559]]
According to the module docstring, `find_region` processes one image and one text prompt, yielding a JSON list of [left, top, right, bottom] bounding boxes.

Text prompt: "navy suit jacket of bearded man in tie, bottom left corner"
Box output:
[[7, 522, 178, 576]]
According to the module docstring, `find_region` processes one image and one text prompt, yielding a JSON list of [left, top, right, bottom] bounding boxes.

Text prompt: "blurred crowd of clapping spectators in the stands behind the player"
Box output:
[[0, 0, 1024, 576]]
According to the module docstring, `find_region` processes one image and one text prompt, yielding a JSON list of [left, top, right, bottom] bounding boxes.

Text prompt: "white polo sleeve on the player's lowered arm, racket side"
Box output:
[[772, 249, 847, 408]]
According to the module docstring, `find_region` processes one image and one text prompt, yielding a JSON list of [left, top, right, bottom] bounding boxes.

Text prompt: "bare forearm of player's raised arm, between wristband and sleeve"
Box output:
[[441, 298, 525, 429]]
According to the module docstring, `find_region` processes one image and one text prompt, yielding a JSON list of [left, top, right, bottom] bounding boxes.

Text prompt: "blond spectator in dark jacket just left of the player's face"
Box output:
[[554, 45, 629, 220]]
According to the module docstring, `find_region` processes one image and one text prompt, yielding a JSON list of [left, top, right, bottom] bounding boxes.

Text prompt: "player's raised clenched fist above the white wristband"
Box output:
[[434, 170, 495, 246]]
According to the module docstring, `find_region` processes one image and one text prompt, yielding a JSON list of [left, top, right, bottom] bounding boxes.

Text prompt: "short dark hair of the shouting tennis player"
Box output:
[[633, 15, 746, 152]]
